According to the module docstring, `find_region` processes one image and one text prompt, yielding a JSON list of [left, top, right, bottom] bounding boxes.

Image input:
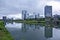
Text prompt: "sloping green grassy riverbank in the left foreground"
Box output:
[[0, 21, 13, 40]]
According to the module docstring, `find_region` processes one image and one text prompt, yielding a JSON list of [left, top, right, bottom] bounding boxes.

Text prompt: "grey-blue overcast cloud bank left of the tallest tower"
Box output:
[[0, 0, 59, 15]]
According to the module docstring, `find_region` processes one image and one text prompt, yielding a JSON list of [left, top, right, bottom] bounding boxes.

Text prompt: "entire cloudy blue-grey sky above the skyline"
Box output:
[[0, 0, 60, 18]]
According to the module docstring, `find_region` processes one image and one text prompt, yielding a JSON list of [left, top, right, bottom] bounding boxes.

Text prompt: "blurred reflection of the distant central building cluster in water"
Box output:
[[22, 23, 40, 32]]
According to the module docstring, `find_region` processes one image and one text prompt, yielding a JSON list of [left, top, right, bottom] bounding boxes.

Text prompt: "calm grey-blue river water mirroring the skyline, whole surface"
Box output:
[[5, 22, 60, 40]]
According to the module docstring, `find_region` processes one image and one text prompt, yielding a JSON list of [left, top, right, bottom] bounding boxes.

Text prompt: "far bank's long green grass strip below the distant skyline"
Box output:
[[14, 20, 45, 25]]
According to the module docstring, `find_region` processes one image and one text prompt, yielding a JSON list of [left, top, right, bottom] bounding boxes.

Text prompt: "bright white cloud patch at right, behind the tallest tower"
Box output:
[[47, 1, 60, 15]]
